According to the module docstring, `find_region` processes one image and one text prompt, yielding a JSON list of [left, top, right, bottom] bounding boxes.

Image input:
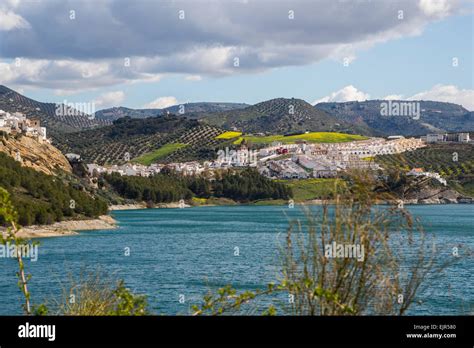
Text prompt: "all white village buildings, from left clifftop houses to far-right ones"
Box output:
[[0, 110, 472, 185]]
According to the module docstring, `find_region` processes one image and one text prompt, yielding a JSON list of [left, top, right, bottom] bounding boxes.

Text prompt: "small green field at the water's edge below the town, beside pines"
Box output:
[[278, 179, 345, 202]]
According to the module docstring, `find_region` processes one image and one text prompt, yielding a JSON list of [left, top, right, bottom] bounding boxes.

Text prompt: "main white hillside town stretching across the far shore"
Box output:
[[83, 137, 432, 179]]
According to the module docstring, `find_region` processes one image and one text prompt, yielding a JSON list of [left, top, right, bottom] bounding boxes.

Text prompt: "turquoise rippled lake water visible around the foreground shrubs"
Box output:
[[0, 205, 474, 315]]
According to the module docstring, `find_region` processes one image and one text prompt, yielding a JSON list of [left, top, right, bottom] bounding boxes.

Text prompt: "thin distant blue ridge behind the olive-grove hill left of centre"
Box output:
[[95, 102, 249, 121]]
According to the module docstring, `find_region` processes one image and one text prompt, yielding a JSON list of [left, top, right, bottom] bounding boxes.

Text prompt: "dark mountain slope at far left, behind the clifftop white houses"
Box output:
[[0, 85, 110, 139]]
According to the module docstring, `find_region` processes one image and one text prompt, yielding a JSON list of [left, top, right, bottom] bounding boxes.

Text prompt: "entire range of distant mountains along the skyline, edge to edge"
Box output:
[[0, 85, 474, 143]]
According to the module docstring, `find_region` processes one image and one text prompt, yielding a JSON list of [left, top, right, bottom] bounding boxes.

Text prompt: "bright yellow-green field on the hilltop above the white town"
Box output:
[[234, 132, 368, 144]]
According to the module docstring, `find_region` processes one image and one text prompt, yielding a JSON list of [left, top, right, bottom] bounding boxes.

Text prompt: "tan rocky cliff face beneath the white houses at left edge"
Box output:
[[0, 135, 72, 175]]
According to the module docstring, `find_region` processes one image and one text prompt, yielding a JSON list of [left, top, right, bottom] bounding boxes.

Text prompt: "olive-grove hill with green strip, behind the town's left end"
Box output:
[[54, 114, 231, 164]]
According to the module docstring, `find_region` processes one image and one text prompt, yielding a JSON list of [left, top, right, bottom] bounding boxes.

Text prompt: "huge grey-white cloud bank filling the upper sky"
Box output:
[[0, 0, 462, 90]]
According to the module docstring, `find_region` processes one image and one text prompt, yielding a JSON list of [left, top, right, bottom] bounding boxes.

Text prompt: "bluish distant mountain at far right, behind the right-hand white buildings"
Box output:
[[315, 100, 474, 136]]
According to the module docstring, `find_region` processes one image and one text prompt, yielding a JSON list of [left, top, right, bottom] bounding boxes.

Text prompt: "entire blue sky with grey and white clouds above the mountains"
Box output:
[[0, 0, 474, 110]]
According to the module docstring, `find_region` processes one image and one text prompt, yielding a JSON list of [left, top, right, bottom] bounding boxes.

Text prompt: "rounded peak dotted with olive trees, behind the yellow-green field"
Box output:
[[194, 98, 371, 134]]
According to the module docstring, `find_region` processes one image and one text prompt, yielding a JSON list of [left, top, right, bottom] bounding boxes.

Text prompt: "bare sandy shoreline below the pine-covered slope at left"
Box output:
[[12, 215, 117, 239]]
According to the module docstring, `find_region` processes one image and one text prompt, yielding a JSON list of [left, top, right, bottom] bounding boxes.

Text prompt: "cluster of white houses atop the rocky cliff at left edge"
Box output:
[[0, 110, 49, 142]]
